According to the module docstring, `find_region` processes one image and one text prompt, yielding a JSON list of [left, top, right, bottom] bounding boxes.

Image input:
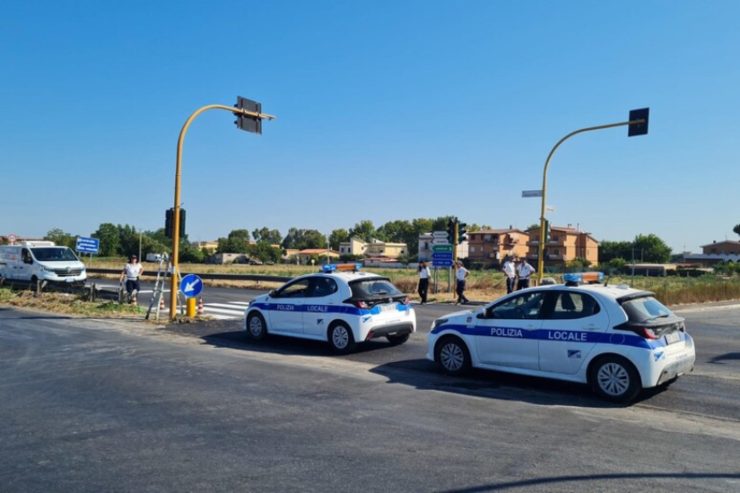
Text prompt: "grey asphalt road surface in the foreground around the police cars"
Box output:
[[0, 305, 740, 492]]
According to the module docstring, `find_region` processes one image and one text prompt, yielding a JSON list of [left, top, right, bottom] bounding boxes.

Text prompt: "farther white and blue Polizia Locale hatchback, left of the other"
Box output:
[[244, 264, 416, 353]]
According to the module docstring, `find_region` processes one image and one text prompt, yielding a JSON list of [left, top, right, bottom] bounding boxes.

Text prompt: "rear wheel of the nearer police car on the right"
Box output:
[[590, 356, 642, 403]]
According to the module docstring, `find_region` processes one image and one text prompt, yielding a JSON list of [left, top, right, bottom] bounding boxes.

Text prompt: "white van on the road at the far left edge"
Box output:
[[0, 241, 87, 284]]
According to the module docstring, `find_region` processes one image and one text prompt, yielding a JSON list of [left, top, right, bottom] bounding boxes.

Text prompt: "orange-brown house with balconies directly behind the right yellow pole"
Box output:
[[527, 226, 599, 266]]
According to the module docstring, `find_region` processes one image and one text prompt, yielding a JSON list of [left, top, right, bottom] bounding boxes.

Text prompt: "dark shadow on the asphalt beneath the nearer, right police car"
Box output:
[[371, 359, 653, 409]]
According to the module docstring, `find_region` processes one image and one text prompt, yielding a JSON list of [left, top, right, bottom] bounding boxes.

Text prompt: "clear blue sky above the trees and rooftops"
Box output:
[[0, 0, 740, 251]]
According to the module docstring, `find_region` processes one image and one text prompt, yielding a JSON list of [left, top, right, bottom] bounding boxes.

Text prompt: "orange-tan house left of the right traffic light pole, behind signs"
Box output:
[[467, 228, 529, 266]]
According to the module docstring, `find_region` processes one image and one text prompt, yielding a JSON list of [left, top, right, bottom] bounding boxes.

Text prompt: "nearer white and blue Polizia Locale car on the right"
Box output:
[[427, 274, 696, 402]]
